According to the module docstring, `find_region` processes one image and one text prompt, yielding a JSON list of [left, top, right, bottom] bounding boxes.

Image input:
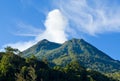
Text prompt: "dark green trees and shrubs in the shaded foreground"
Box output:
[[0, 47, 115, 81]]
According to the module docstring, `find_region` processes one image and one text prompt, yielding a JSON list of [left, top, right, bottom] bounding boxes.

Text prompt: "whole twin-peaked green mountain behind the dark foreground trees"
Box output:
[[22, 38, 120, 72]]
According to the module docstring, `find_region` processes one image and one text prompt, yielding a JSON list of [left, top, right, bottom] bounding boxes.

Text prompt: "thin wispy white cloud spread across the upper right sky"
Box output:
[[56, 0, 120, 35]]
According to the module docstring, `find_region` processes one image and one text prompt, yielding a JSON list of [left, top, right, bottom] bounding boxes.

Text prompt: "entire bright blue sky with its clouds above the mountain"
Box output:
[[0, 0, 120, 60]]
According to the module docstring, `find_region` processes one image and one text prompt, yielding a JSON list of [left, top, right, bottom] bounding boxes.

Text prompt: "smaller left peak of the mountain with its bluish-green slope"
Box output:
[[22, 39, 61, 57]]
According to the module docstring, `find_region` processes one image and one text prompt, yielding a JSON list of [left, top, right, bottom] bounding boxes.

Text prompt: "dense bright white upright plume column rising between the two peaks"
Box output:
[[36, 9, 67, 43]]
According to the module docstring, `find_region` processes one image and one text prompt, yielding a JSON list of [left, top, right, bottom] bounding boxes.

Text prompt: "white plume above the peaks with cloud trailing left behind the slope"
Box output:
[[3, 9, 67, 51]]
